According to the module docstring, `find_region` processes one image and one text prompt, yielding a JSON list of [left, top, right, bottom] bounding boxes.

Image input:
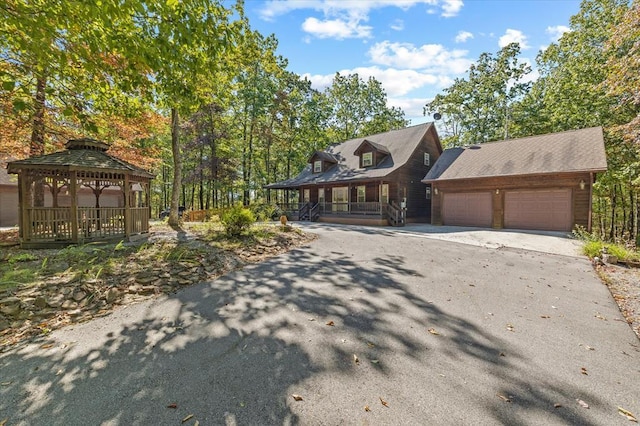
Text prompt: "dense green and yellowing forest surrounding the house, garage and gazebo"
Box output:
[[0, 0, 640, 244]]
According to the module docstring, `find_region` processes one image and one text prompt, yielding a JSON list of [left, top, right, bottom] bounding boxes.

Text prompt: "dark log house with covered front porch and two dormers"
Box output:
[[265, 123, 442, 225]]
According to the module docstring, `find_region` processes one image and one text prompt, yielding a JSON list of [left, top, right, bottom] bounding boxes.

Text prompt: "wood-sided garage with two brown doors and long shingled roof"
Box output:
[[422, 127, 607, 231]]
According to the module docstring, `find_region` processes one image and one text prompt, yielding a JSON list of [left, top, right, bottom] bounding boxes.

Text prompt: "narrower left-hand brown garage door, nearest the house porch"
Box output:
[[442, 192, 492, 227]]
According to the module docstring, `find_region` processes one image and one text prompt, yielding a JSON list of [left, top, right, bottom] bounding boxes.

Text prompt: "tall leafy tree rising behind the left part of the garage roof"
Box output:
[[424, 43, 531, 146]]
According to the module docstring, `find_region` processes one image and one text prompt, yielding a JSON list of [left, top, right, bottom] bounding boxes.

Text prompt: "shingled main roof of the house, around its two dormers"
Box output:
[[265, 123, 433, 189]]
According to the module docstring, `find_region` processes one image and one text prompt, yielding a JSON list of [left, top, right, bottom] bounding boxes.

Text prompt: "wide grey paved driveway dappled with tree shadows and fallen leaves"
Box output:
[[0, 224, 640, 425]]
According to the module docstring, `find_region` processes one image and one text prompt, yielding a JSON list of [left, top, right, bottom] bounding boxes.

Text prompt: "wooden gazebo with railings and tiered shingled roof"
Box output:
[[7, 138, 154, 248]]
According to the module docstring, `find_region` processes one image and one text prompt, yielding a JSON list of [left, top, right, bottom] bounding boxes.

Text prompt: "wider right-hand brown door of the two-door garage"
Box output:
[[504, 189, 573, 231]]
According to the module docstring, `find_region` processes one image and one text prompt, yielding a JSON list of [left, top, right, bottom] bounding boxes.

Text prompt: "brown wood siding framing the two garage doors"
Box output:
[[431, 172, 593, 230]]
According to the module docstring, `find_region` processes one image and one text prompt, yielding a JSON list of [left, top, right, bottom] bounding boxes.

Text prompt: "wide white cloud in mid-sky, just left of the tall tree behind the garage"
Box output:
[[369, 41, 472, 74]]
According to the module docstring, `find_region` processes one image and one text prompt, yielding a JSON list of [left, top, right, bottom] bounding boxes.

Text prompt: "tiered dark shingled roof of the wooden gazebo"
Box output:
[[7, 138, 154, 178]]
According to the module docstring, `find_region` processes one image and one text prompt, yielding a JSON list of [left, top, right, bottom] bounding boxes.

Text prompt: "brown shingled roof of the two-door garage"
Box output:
[[422, 127, 607, 183]]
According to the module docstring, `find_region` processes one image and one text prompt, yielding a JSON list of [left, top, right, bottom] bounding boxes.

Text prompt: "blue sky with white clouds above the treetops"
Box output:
[[245, 0, 580, 124]]
